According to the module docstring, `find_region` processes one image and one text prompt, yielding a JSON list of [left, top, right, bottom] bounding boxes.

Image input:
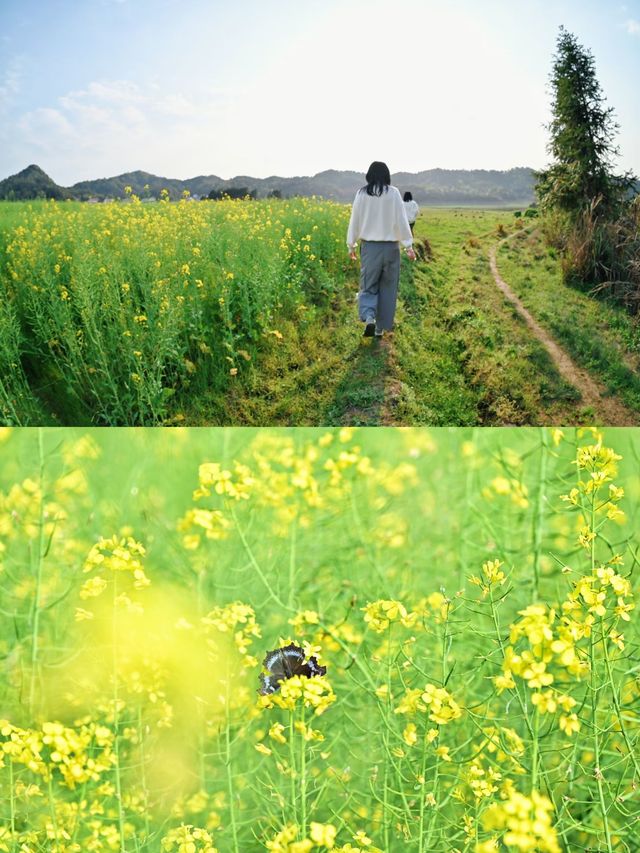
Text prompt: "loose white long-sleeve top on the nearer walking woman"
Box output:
[[347, 187, 413, 249]]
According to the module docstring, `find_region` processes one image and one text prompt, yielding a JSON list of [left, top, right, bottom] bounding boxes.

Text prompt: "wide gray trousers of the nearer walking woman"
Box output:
[[358, 240, 400, 332]]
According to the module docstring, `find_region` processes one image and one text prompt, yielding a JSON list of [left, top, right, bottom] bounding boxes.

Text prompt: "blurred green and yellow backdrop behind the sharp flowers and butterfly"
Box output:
[[0, 428, 640, 853]]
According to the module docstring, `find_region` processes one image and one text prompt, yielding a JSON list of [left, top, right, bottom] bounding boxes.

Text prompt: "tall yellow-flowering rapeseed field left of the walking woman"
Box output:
[[0, 196, 348, 425]]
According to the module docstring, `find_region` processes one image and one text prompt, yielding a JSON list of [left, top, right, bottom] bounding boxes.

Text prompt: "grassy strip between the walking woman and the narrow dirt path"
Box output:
[[390, 211, 577, 425]]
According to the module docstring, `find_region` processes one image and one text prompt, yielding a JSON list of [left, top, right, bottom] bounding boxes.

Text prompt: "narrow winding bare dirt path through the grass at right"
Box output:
[[489, 232, 637, 426]]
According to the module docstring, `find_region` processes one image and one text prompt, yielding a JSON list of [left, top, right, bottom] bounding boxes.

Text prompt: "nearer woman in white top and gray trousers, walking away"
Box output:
[[347, 161, 416, 338]]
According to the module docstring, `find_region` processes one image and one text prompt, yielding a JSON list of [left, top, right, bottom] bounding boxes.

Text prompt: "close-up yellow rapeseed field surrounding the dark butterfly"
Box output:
[[0, 426, 640, 853]]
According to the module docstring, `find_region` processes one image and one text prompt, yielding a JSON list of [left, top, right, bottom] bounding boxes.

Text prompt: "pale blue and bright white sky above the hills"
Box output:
[[0, 0, 640, 185]]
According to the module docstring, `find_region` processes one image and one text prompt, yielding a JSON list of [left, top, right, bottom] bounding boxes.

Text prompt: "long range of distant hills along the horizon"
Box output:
[[0, 166, 534, 207]]
